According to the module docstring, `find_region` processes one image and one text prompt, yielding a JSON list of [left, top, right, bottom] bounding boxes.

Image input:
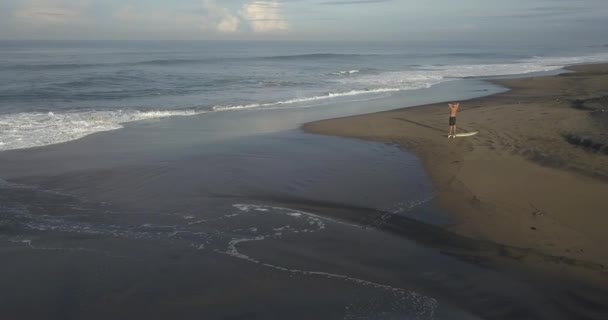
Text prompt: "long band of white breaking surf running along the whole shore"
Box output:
[[0, 54, 608, 151]]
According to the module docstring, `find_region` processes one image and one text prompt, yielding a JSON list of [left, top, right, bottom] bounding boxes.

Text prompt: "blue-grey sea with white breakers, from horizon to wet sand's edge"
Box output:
[[0, 41, 608, 150]]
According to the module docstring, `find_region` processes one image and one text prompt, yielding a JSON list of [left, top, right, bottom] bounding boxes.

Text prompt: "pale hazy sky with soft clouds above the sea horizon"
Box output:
[[0, 0, 608, 43]]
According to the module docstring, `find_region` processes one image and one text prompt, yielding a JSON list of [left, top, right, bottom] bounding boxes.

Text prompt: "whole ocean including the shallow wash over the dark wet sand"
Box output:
[[0, 41, 608, 319]]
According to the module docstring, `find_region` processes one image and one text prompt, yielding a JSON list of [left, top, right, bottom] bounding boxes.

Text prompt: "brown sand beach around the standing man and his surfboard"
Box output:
[[302, 64, 608, 266]]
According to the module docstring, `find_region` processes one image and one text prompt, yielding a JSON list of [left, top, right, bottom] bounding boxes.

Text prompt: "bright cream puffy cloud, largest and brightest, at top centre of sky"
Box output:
[[241, 0, 289, 33]]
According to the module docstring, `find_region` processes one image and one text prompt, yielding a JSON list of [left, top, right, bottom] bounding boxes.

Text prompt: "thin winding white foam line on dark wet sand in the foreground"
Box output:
[[216, 204, 438, 319]]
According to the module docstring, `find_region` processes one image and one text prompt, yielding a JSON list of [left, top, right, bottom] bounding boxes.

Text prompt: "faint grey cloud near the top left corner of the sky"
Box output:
[[14, 0, 89, 26]]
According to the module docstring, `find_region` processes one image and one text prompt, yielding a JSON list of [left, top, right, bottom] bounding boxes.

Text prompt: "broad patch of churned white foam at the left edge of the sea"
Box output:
[[0, 110, 201, 151]]
